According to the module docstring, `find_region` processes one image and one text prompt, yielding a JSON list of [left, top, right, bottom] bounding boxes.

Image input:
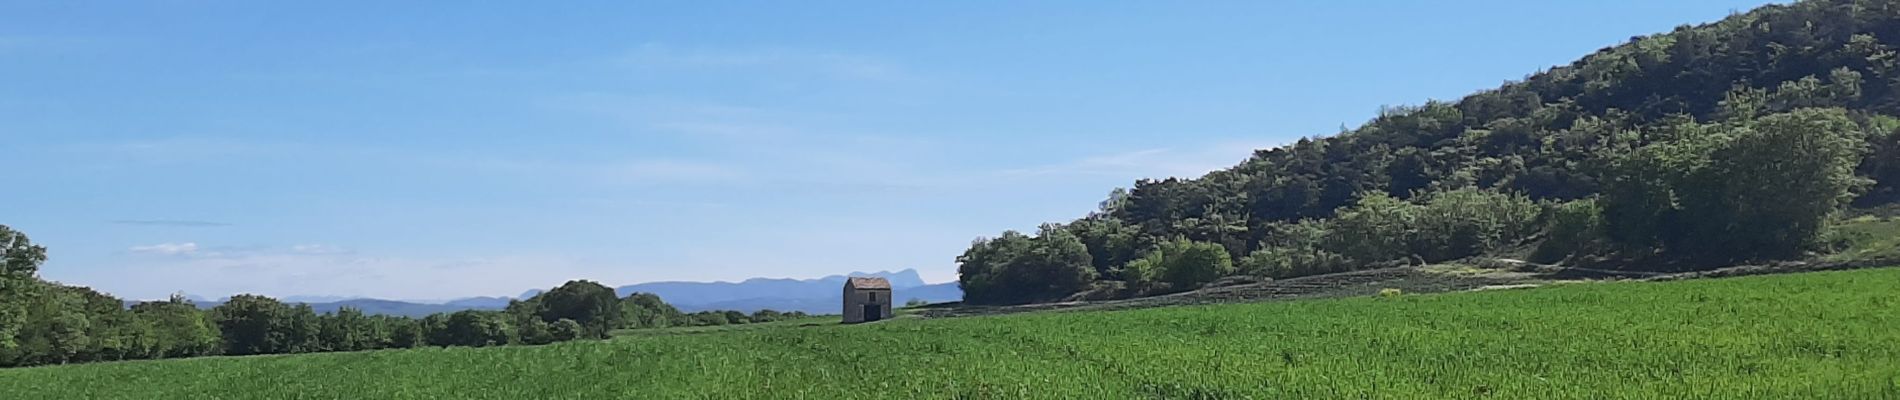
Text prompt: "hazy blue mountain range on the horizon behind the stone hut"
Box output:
[[155, 269, 963, 317]]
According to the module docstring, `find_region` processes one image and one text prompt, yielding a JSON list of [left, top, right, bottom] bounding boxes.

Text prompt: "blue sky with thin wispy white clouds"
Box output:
[[0, 0, 1759, 300]]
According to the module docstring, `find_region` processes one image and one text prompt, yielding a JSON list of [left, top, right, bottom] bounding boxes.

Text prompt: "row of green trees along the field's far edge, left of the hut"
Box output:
[[0, 226, 806, 368]]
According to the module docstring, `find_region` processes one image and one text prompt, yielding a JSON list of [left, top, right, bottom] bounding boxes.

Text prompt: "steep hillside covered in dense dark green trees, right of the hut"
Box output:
[[958, 0, 1900, 303]]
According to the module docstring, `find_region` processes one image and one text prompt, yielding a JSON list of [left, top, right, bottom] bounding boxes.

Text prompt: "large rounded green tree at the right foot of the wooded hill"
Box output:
[[1602, 108, 1864, 264]]
